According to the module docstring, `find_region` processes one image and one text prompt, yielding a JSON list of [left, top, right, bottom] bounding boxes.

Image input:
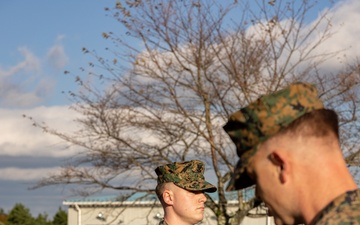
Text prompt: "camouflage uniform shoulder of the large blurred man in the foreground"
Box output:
[[311, 189, 360, 225]]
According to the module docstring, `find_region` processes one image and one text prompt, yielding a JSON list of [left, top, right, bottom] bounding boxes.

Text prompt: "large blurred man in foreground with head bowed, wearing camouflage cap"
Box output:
[[224, 83, 360, 225]]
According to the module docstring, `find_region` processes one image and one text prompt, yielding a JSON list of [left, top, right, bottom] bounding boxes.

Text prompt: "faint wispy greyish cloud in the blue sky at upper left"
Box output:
[[0, 35, 68, 107]]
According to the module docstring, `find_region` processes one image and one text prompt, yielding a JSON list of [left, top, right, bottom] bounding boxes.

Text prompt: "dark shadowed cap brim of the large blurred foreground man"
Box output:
[[226, 160, 255, 191]]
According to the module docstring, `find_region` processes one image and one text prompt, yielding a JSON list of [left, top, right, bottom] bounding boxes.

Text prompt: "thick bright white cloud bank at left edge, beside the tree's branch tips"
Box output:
[[0, 106, 81, 157]]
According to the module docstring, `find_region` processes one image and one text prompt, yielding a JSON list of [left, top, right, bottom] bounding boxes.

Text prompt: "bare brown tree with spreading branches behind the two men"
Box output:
[[28, 0, 360, 224]]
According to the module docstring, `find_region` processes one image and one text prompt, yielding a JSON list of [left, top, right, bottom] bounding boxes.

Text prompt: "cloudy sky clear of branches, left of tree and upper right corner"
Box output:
[[0, 0, 360, 219]]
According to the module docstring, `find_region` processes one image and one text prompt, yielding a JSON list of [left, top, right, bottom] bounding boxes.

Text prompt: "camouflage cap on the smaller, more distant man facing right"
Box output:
[[155, 160, 217, 192]]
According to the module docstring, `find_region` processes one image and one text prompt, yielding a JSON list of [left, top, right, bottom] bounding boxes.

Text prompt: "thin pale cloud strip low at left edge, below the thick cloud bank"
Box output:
[[0, 167, 60, 181]]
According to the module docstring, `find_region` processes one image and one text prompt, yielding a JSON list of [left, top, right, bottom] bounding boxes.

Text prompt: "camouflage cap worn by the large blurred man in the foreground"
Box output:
[[223, 83, 324, 191]]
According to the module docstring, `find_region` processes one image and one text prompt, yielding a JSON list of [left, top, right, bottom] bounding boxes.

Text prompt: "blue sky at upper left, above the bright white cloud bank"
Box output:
[[0, 0, 119, 107]]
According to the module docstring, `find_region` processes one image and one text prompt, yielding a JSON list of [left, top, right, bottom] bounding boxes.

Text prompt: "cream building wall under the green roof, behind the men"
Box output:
[[68, 205, 275, 225]]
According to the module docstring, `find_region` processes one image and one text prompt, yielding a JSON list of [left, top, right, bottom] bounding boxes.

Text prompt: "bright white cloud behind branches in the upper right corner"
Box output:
[[233, 0, 360, 79]]
